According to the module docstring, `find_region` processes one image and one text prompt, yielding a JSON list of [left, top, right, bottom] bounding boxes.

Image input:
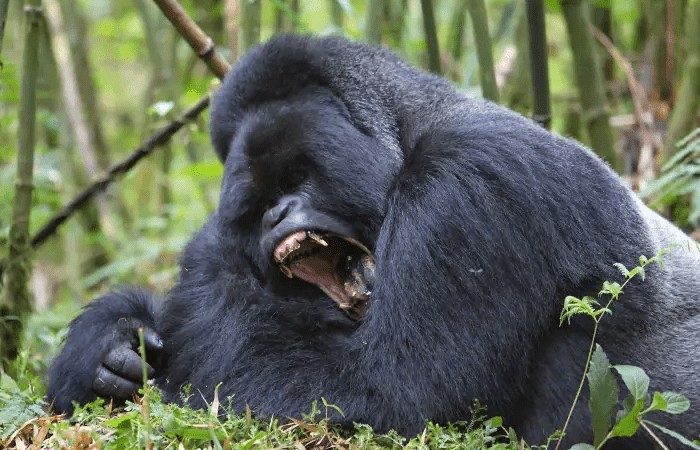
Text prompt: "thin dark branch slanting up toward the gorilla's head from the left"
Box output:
[[31, 95, 209, 248]]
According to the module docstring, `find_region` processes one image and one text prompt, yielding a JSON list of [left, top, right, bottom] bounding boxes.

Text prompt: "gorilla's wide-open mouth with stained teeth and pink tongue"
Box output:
[[273, 231, 374, 320]]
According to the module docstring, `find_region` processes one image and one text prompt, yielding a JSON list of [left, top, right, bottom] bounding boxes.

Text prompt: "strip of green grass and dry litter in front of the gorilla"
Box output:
[[0, 374, 525, 450]]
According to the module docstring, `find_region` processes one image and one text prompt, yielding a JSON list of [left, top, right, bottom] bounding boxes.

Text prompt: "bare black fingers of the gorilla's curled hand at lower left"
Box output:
[[92, 317, 163, 400]]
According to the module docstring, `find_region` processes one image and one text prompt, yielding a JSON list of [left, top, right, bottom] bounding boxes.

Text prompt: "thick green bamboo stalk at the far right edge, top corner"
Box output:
[[664, 0, 700, 158]]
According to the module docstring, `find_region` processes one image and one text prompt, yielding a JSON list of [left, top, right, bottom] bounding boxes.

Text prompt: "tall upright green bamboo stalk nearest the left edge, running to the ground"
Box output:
[[0, 0, 42, 360]]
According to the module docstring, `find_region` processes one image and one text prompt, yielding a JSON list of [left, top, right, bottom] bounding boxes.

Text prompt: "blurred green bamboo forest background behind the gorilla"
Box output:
[[0, 0, 700, 373]]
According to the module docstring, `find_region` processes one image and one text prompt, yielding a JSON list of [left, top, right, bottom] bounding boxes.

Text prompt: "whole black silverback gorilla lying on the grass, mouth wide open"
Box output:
[[48, 36, 700, 448]]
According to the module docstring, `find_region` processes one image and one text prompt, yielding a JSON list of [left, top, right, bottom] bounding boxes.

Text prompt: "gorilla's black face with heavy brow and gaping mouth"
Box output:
[[219, 89, 398, 318]]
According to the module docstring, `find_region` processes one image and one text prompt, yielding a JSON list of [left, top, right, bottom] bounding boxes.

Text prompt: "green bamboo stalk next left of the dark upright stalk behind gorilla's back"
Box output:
[[467, 0, 498, 102]]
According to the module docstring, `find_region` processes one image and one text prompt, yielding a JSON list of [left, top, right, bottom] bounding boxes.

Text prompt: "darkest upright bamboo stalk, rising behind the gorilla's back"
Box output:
[[526, 0, 552, 129]]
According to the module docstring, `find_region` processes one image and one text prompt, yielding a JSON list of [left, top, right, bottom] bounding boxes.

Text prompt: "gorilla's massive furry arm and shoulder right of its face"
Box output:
[[350, 120, 650, 432]]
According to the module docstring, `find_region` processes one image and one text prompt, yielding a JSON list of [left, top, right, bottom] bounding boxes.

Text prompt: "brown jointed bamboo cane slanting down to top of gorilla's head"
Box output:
[[153, 0, 231, 78]]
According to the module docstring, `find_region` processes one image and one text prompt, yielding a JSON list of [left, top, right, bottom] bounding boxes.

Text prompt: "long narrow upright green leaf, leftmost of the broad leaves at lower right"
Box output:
[[586, 344, 619, 446]]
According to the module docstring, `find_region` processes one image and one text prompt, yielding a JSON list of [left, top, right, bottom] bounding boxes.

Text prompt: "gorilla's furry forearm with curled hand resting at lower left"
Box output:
[[47, 289, 163, 414]]
